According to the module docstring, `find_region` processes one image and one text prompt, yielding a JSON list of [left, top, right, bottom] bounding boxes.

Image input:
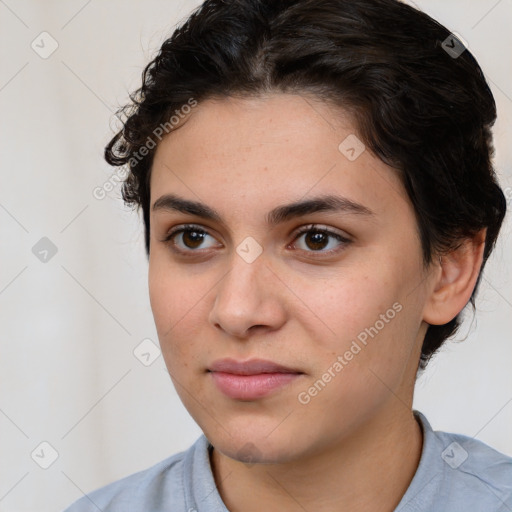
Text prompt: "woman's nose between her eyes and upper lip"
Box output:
[[209, 253, 286, 339]]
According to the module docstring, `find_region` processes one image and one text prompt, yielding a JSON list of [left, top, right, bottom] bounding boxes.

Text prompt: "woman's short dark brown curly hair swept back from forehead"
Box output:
[[105, 0, 506, 369]]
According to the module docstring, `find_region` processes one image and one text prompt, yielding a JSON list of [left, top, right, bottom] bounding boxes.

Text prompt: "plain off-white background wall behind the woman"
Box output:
[[0, 0, 512, 512]]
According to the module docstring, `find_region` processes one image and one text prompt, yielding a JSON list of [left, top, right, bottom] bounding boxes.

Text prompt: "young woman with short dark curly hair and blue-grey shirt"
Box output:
[[64, 0, 512, 512]]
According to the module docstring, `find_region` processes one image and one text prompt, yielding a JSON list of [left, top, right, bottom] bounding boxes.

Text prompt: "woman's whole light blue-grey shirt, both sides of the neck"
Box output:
[[64, 411, 512, 512]]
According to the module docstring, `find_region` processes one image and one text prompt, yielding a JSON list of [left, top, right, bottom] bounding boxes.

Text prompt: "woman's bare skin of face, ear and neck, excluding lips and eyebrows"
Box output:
[[149, 93, 485, 512]]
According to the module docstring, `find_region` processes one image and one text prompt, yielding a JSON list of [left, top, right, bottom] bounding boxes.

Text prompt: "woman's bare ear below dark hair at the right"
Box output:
[[423, 228, 487, 325]]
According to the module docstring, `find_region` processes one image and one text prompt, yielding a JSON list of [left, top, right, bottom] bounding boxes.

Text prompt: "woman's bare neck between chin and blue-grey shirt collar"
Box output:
[[210, 401, 423, 512]]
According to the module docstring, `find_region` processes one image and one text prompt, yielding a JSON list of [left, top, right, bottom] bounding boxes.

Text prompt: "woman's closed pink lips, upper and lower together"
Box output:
[[208, 359, 304, 400]]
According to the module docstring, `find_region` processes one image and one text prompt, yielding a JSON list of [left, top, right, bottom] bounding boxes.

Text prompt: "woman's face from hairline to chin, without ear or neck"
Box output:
[[149, 94, 431, 462]]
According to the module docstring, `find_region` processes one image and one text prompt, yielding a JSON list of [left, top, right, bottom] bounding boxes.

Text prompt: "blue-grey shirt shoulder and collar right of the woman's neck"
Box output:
[[397, 411, 512, 512]]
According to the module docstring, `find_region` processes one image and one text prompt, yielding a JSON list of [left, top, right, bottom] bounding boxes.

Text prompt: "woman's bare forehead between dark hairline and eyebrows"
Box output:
[[151, 94, 408, 222]]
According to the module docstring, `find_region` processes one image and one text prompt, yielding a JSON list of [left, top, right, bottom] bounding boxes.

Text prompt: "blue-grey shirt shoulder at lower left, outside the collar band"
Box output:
[[60, 436, 207, 512]]
